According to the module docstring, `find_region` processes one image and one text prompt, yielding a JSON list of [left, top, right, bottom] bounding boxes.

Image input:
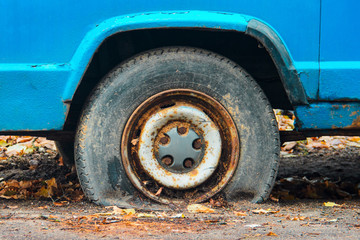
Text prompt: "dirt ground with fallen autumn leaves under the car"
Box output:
[[0, 141, 360, 239]]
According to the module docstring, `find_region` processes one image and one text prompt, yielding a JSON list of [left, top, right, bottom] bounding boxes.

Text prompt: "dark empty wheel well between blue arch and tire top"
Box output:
[[64, 29, 291, 131]]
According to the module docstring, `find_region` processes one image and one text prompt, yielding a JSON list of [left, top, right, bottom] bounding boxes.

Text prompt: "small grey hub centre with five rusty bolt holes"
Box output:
[[158, 127, 203, 173]]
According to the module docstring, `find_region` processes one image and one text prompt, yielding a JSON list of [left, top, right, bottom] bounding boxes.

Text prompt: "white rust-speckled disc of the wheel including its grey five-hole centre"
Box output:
[[137, 103, 222, 189]]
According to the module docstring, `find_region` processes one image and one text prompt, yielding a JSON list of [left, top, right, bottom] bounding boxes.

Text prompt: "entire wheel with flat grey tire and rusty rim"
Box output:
[[75, 47, 279, 207]]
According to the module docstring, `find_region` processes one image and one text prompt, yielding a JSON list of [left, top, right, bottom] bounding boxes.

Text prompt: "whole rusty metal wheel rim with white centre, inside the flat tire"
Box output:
[[121, 89, 240, 204]]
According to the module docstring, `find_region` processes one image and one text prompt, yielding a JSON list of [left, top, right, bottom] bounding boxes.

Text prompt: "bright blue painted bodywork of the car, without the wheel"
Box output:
[[0, 0, 360, 132]]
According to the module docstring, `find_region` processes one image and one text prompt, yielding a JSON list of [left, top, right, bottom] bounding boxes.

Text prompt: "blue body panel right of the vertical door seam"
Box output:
[[319, 0, 360, 101]]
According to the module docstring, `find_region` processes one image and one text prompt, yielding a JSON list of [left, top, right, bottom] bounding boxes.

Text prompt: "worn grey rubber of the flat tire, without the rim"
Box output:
[[76, 48, 278, 205]]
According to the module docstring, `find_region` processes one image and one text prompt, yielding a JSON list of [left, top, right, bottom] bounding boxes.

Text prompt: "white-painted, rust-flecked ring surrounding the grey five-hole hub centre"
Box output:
[[138, 106, 222, 189]]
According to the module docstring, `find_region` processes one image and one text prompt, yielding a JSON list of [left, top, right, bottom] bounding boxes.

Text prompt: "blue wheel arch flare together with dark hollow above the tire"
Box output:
[[63, 11, 307, 130]]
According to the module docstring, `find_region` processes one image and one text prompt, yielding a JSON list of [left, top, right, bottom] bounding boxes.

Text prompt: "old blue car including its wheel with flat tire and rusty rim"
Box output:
[[0, 0, 360, 206]]
